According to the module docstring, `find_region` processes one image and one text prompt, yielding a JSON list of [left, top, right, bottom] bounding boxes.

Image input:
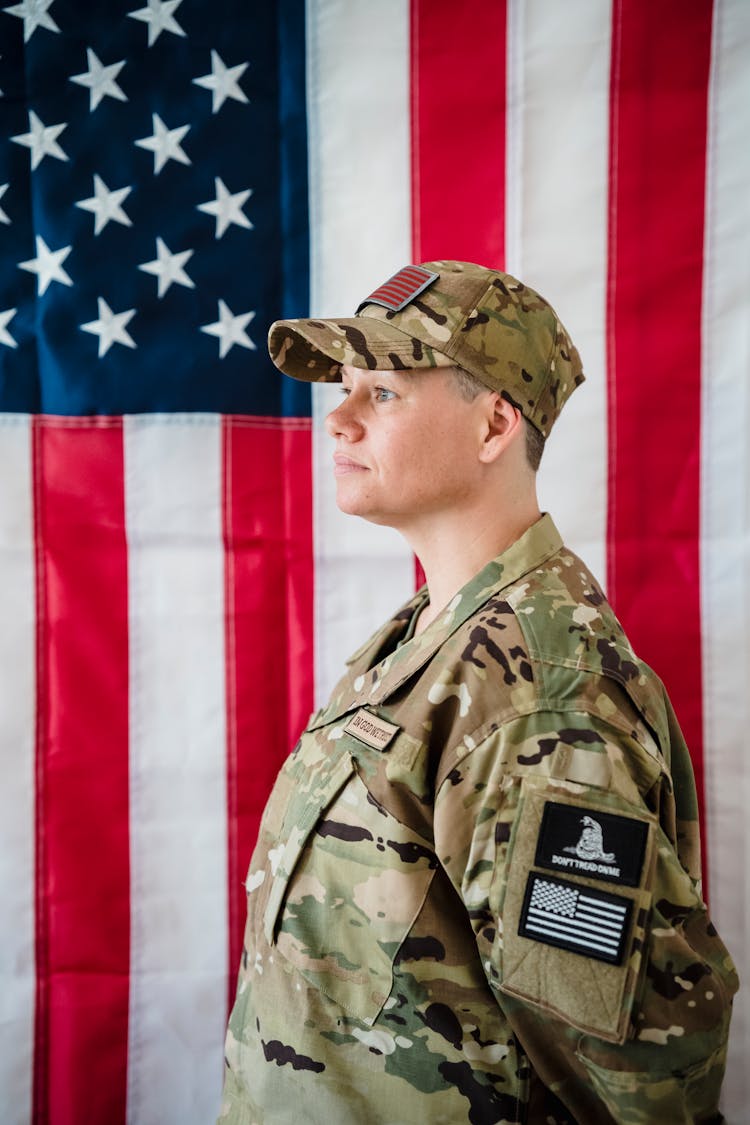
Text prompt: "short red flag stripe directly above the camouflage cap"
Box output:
[[412, 0, 506, 266]]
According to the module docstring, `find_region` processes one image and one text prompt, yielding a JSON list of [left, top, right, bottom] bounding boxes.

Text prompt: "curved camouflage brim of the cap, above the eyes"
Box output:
[[269, 315, 453, 383]]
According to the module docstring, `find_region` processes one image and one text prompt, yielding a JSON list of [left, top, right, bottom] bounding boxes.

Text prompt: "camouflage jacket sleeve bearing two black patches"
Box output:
[[435, 712, 738, 1125]]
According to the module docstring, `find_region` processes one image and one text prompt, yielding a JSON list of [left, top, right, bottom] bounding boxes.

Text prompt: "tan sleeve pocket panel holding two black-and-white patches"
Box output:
[[493, 777, 653, 1043]]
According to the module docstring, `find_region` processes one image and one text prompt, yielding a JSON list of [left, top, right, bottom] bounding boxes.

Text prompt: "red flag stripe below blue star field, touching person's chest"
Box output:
[[224, 417, 314, 1002]]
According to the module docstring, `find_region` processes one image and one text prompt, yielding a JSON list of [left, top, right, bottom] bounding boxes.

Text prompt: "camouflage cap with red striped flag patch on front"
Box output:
[[269, 261, 584, 437]]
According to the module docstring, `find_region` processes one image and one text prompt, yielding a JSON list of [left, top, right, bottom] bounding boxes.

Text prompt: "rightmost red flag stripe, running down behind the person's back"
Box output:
[[608, 0, 712, 839]]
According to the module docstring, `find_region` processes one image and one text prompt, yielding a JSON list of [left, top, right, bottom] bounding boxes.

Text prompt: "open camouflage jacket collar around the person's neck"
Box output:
[[309, 514, 562, 730]]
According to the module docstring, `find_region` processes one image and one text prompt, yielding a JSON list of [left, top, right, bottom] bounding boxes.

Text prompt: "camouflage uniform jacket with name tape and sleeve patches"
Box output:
[[220, 516, 737, 1125]]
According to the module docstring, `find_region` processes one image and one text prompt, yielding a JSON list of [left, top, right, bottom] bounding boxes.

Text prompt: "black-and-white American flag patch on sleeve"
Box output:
[[518, 872, 633, 965]]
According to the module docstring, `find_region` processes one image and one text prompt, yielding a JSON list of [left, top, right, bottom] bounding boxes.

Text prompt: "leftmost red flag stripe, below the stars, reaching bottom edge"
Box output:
[[34, 419, 130, 1125]]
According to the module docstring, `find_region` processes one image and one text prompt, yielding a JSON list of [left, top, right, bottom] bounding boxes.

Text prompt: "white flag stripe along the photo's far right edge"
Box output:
[[701, 0, 750, 1122]]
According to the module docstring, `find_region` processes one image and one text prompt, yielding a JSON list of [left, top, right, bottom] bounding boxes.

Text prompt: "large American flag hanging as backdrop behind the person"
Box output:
[[0, 0, 750, 1125]]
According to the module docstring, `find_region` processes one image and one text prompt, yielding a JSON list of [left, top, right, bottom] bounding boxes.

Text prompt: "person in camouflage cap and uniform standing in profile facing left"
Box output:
[[219, 261, 737, 1125]]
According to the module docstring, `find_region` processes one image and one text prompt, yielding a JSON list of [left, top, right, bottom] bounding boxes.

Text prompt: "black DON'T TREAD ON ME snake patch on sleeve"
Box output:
[[534, 801, 649, 887]]
